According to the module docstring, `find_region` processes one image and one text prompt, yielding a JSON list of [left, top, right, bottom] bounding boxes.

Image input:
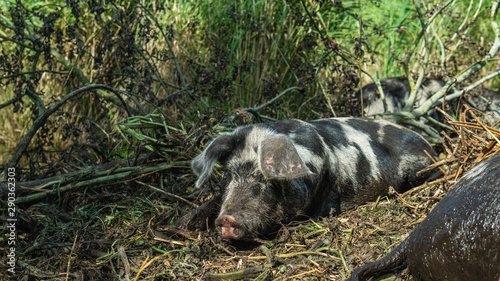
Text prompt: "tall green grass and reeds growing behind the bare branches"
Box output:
[[0, 0, 500, 166]]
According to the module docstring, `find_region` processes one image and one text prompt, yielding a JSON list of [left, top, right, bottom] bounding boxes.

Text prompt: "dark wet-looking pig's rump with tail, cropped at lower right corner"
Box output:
[[349, 155, 500, 281]]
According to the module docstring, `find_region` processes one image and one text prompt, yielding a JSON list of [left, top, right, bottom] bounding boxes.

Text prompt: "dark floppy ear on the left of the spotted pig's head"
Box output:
[[191, 135, 234, 188]]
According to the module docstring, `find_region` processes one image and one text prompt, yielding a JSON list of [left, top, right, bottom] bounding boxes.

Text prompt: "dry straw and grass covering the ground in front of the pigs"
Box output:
[[4, 108, 500, 280]]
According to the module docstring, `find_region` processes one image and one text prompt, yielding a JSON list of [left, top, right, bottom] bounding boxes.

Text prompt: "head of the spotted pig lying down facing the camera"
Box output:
[[192, 126, 312, 240]]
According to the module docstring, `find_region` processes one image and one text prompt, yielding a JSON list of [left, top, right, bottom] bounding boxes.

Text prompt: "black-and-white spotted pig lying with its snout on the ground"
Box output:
[[192, 118, 434, 240]]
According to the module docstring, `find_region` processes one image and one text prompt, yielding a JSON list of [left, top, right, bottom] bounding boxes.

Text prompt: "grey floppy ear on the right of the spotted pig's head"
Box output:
[[259, 135, 312, 179]]
